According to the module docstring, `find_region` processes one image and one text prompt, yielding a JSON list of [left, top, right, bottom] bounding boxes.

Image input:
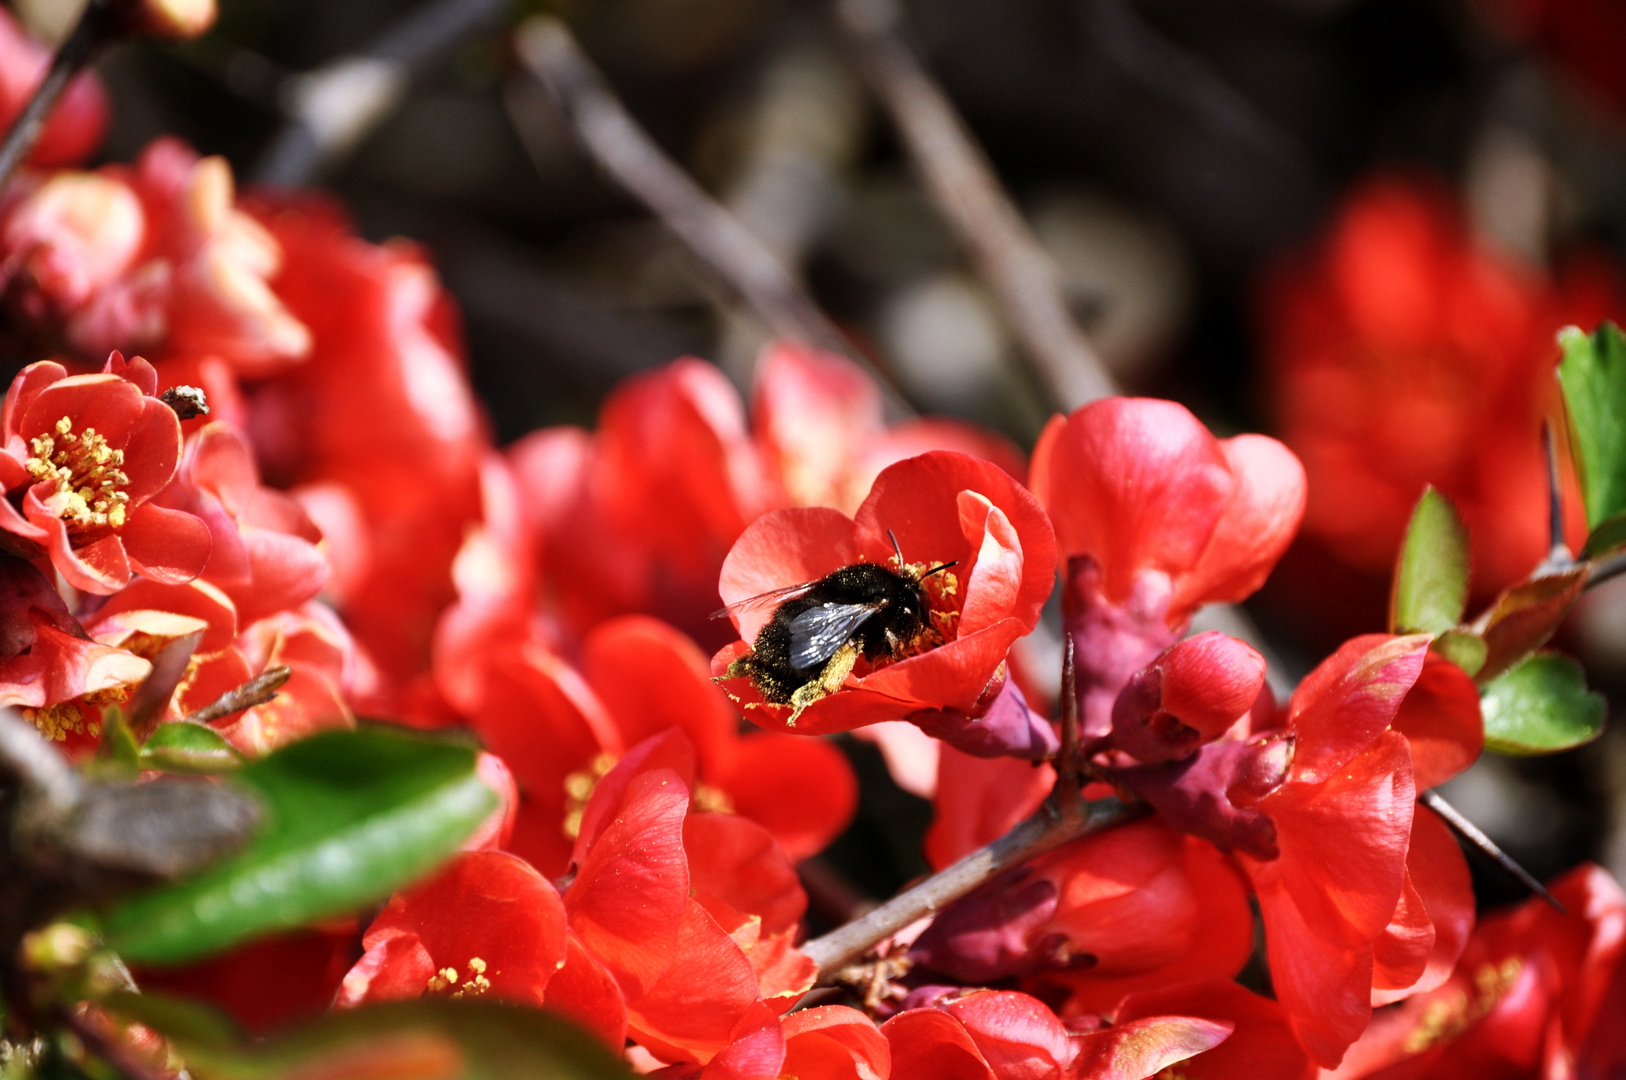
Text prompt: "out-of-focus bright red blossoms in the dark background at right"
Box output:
[[1263, 177, 1626, 625]]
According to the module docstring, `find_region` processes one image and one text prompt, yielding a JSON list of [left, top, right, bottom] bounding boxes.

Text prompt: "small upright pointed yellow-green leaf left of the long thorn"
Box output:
[[1389, 486, 1468, 634]]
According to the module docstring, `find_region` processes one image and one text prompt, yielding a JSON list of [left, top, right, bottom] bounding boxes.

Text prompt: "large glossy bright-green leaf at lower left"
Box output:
[[104, 729, 498, 965]]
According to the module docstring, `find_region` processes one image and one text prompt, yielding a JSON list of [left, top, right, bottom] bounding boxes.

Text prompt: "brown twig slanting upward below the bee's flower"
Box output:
[[802, 799, 1146, 979]]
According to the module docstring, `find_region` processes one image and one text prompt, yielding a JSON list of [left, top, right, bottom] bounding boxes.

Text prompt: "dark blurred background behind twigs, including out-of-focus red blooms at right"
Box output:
[[22, 0, 1626, 903]]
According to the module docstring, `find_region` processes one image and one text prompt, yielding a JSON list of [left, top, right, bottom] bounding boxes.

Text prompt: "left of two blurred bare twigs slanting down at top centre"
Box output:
[[515, 16, 914, 415]]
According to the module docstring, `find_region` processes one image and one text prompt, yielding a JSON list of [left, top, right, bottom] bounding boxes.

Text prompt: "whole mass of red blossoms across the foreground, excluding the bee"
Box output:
[[0, 15, 1626, 1080]]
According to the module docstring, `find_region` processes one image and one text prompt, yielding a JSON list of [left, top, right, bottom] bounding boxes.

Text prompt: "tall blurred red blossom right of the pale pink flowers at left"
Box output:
[[249, 191, 486, 692]]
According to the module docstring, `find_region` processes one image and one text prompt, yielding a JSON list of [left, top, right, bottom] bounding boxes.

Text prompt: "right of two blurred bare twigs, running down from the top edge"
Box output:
[[836, 0, 1114, 412]]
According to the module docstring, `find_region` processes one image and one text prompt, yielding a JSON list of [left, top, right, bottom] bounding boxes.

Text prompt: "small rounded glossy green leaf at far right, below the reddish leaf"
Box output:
[[1480, 652, 1605, 755]]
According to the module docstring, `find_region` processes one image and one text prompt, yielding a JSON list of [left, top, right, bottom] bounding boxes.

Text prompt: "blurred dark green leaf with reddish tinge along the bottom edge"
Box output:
[[106, 994, 633, 1080]]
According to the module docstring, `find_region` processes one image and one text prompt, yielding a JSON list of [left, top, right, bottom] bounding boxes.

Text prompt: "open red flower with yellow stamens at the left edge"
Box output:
[[0, 353, 210, 594]]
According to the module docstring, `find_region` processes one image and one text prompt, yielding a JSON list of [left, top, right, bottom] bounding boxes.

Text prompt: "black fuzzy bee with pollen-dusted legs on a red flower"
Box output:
[[712, 529, 958, 724]]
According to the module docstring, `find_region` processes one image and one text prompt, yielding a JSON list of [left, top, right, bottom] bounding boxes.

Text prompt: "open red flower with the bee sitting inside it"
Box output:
[[712, 451, 1055, 734]]
